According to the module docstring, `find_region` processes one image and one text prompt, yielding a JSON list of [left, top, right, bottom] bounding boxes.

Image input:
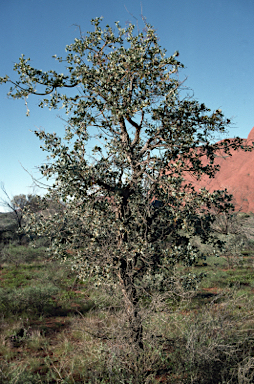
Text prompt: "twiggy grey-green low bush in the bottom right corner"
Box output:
[[165, 291, 254, 384]]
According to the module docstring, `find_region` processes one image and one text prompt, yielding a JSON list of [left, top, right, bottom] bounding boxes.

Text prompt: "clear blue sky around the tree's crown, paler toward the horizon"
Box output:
[[0, 0, 254, 210]]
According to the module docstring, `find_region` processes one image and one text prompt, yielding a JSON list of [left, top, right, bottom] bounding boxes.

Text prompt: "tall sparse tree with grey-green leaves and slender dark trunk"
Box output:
[[1, 18, 251, 350]]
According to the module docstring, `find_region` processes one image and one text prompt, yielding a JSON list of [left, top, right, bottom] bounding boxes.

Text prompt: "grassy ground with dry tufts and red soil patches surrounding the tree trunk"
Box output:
[[0, 220, 254, 384]]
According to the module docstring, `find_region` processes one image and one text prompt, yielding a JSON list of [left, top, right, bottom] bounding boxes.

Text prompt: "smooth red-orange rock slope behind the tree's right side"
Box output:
[[182, 127, 254, 212]]
